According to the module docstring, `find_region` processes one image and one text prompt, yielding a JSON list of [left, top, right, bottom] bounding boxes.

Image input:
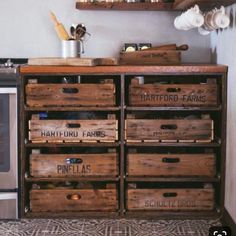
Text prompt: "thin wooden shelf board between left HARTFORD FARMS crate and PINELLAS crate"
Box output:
[[25, 142, 120, 148]]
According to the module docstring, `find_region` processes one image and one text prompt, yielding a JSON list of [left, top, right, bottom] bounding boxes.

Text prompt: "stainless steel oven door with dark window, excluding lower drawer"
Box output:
[[0, 88, 18, 191]]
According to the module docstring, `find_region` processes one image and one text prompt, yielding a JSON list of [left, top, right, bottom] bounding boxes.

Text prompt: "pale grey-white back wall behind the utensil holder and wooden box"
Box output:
[[0, 0, 210, 62]]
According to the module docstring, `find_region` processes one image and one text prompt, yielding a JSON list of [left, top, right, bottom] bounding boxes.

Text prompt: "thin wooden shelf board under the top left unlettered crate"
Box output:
[[25, 107, 120, 111]]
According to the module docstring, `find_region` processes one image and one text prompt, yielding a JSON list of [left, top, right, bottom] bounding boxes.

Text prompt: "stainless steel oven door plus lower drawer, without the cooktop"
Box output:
[[0, 87, 18, 219]]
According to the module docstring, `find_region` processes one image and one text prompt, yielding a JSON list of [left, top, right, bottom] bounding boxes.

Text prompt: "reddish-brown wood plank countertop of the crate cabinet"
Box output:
[[20, 64, 228, 75]]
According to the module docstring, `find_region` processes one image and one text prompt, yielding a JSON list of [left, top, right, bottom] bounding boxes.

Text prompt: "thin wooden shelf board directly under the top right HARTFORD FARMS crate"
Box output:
[[126, 106, 221, 112]]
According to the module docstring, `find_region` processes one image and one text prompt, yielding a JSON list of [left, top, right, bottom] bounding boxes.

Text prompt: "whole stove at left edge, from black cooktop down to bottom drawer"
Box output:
[[0, 59, 27, 219]]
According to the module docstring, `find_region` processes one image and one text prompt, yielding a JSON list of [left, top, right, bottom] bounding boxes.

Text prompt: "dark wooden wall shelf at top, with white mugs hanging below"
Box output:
[[76, 0, 236, 11]]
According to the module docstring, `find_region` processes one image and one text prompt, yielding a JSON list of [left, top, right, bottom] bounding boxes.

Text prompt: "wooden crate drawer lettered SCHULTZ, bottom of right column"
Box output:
[[127, 188, 214, 211]]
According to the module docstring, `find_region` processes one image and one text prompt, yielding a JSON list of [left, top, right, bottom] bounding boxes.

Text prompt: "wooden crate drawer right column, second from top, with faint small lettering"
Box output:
[[126, 119, 214, 142]]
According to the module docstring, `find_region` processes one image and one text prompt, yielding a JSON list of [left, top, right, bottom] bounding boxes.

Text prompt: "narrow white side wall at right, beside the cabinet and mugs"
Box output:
[[211, 5, 236, 222]]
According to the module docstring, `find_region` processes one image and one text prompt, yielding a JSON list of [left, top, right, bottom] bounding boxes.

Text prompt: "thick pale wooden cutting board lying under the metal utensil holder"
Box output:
[[28, 57, 118, 66]]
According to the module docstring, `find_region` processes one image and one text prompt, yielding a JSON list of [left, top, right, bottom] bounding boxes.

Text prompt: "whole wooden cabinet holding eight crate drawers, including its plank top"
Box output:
[[20, 65, 227, 219]]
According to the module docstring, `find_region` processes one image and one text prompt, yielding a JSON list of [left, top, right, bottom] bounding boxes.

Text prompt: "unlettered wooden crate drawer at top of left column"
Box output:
[[25, 83, 116, 107]]
